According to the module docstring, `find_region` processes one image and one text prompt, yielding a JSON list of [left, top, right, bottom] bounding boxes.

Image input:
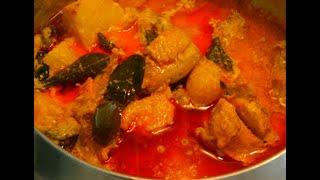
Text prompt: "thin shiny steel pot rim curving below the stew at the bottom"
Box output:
[[34, 128, 286, 180]]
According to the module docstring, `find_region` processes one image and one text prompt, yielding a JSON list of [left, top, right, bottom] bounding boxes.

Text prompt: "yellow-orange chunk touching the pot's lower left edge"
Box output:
[[34, 92, 80, 140]]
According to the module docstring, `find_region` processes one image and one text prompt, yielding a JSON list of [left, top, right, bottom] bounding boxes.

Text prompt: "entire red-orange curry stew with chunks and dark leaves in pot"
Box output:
[[34, 0, 286, 179]]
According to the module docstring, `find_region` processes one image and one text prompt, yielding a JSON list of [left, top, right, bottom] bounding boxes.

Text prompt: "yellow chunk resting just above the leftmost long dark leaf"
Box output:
[[43, 38, 80, 76]]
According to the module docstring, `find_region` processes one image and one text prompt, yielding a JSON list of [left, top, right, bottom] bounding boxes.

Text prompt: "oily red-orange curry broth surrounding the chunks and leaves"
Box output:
[[36, 0, 286, 179]]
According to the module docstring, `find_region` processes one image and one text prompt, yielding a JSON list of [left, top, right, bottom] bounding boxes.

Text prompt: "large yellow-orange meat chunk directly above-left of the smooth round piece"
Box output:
[[142, 29, 200, 92]]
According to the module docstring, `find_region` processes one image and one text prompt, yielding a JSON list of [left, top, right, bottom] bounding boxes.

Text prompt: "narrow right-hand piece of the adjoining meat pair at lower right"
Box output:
[[234, 98, 278, 143]]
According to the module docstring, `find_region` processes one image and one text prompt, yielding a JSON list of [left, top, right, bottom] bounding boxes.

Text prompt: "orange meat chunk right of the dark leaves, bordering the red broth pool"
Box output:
[[121, 89, 174, 133]]
